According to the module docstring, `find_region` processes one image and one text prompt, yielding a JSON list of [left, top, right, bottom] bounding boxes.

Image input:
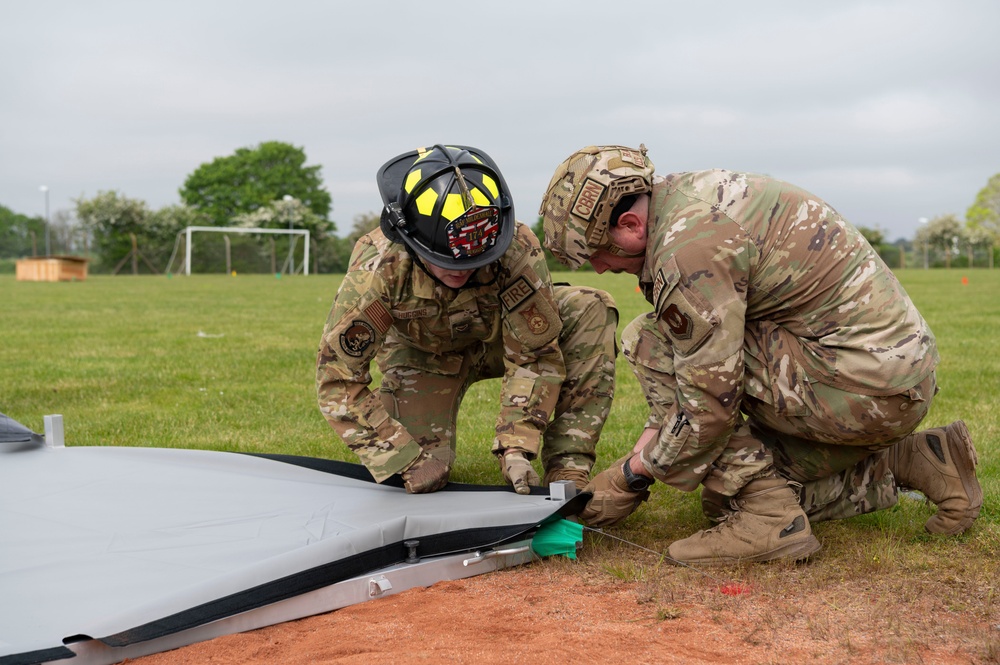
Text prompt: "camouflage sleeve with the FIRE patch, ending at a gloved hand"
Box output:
[[493, 224, 566, 457]]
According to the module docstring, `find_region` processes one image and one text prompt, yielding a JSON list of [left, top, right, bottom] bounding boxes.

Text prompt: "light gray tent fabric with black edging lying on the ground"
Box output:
[[0, 419, 580, 665]]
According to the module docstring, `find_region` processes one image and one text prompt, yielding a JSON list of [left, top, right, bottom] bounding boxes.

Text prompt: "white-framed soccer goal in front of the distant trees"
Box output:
[[166, 226, 310, 275]]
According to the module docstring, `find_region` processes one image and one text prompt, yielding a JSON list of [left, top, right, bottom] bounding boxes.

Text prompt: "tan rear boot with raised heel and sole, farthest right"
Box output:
[[889, 420, 983, 536]]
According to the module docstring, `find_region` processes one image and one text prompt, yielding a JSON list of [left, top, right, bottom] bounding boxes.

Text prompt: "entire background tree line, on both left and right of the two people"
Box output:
[[0, 146, 1000, 273]]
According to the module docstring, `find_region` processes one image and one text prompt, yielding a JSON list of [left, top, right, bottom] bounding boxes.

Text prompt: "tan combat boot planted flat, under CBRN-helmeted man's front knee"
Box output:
[[669, 478, 820, 565]]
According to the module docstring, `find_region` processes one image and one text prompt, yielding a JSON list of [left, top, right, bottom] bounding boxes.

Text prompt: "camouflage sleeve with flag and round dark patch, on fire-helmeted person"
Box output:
[[316, 238, 420, 482]]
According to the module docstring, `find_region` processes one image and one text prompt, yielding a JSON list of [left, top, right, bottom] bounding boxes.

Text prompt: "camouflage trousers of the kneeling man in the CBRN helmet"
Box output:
[[622, 316, 936, 521]]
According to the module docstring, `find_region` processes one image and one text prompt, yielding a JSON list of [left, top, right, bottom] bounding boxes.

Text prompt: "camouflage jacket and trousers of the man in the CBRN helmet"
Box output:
[[622, 170, 938, 520]]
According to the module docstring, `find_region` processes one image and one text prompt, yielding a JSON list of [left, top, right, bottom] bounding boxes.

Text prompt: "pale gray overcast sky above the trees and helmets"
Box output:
[[0, 0, 1000, 239]]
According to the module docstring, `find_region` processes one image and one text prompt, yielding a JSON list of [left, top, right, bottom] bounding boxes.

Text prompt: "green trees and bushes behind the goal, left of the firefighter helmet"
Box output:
[[0, 141, 378, 273]]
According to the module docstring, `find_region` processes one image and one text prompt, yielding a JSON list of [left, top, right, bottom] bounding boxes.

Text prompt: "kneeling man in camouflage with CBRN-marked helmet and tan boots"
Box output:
[[540, 146, 982, 563]]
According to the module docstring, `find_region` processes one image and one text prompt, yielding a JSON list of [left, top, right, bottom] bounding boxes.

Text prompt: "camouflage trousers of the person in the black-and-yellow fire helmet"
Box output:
[[379, 285, 618, 472]]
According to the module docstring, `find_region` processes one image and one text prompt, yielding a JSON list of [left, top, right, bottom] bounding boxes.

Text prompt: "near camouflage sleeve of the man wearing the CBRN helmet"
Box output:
[[642, 215, 749, 490]]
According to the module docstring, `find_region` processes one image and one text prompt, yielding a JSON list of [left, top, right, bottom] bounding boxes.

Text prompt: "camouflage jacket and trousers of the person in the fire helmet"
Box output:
[[316, 223, 618, 482]]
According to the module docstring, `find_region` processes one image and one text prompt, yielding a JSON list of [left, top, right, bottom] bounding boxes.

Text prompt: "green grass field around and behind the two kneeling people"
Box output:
[[0, 270, 1000, 662]]
